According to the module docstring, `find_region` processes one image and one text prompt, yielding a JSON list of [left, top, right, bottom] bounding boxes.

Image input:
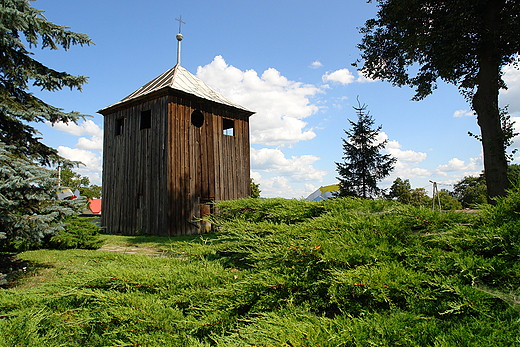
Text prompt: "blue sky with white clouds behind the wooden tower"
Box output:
[[29, 0, 520, 198]]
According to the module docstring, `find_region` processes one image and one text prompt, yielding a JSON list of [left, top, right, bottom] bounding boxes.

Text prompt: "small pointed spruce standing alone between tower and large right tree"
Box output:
[[336, 101, 396, 199]]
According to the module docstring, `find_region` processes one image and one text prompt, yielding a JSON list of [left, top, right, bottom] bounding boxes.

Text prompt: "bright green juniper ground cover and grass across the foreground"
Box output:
[[0, 192, 520, 346]]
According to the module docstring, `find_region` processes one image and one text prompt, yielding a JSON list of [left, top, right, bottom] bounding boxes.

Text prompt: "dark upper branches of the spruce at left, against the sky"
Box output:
[[0, 0, 92, 164]]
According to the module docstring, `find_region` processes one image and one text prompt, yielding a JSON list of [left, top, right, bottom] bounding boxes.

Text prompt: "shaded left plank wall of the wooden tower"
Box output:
[[102, 97, 168, 235]]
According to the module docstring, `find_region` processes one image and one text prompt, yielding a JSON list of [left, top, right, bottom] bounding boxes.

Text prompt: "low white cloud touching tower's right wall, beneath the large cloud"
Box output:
[[251, 148, 327, 182]]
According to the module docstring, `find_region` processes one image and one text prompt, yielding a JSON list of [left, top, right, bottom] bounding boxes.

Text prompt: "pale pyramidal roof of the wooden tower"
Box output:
[[101, 64, 253, 113]]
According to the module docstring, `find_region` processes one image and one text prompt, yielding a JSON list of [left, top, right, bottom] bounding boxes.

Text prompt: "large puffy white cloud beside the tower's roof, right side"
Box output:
[[197, 56, 321, 146]]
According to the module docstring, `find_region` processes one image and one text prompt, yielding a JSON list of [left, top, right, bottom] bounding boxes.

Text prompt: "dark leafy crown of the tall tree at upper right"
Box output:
[[358, 0, 520, 99]]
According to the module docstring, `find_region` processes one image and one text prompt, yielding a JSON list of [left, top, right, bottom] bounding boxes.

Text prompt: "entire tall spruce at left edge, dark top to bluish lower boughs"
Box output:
[[0, 0, 92, 246]]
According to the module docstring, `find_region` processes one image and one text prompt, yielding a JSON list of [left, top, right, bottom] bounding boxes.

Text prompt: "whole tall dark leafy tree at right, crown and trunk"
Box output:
[[358, 0, 520, 197]]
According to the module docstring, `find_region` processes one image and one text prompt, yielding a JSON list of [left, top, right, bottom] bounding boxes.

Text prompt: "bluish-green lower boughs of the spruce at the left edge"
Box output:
[[0, 142, 75, 249]]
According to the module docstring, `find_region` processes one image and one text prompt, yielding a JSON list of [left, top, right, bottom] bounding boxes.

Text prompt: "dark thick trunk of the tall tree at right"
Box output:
[[473, 0, 509, 202]]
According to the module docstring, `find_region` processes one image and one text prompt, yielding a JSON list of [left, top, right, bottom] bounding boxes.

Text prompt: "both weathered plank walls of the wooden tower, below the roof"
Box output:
[[103, 90, 250, 235]]
